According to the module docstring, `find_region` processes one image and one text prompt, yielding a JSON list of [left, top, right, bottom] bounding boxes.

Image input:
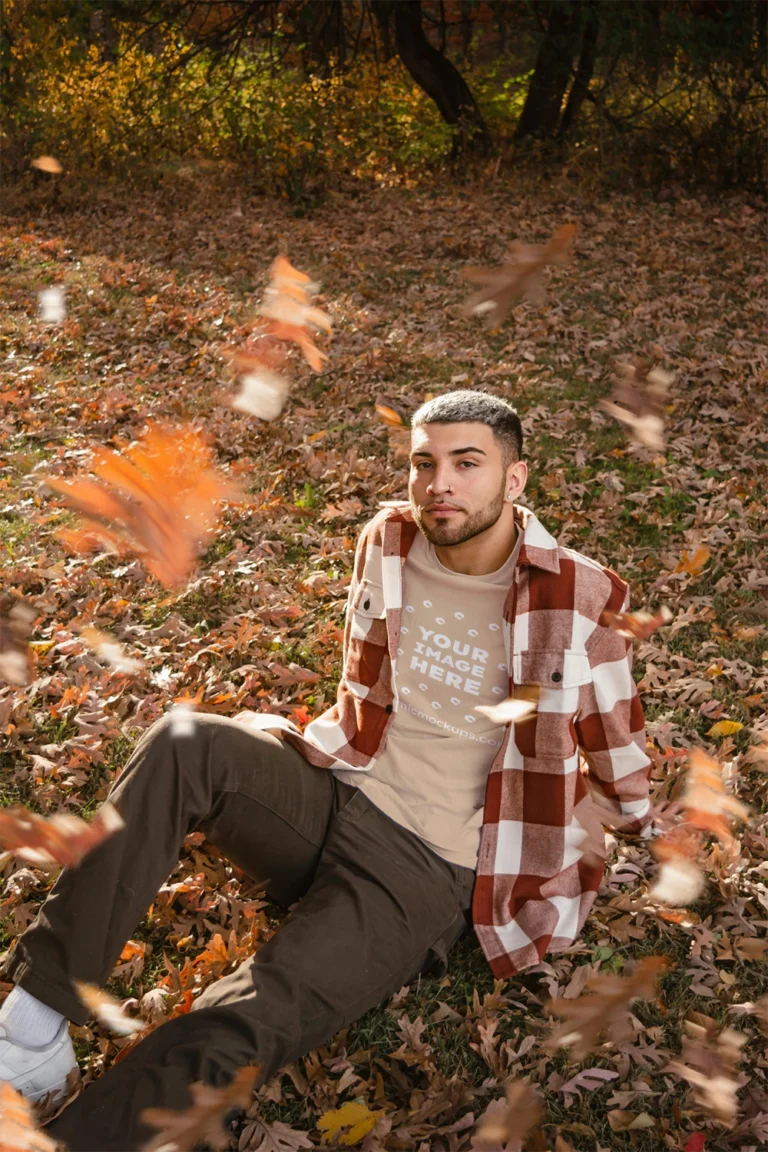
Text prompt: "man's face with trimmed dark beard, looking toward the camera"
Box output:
[[408, 423, 512, 547]]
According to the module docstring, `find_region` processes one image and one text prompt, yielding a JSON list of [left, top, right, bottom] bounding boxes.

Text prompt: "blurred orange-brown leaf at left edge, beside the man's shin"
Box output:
[[0, 803, 123, 869]]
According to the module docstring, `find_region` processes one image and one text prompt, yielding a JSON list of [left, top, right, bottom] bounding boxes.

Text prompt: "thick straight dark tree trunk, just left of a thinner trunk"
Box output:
[[516, 0, 581, 139]]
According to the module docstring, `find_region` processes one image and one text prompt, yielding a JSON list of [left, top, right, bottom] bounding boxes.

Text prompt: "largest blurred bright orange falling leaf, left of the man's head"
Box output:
[[46, 425, 238, 586]]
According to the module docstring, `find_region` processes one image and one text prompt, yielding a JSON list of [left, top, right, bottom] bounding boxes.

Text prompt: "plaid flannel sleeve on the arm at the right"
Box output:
[[576, 592, 652, 835]]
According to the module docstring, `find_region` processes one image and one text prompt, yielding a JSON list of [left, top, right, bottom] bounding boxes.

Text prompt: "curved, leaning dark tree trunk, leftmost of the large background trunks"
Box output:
[[395, 0, 491, 152]]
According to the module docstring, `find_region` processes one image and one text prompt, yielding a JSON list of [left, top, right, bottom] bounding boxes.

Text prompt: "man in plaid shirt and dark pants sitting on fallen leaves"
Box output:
[[0, 389, 651, 1152]]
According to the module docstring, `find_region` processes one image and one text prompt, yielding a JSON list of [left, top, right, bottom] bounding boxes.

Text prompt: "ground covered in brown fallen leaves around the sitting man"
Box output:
[[0, 172, 768, 1152]]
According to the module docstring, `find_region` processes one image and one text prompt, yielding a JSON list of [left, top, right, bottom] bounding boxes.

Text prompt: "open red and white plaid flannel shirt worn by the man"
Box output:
[[283, 503, 651, 977]]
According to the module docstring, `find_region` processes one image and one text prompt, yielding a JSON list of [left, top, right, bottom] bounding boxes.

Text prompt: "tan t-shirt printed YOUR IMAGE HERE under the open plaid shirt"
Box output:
[[334, 532, 522, 869]]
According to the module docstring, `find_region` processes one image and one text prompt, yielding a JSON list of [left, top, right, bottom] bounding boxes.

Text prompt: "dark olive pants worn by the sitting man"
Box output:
[[10, 715, 474, 1152]]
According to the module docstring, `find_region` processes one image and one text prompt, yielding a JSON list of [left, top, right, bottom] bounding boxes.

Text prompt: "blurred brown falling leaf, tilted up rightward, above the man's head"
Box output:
[[462, 223, 577, 328]]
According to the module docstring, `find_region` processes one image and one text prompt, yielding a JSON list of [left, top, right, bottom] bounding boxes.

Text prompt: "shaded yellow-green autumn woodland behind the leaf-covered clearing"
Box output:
[[0, 0, 768, 194]]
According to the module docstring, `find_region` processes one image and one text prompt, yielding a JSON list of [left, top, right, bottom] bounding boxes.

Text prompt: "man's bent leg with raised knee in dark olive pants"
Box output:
[[0, 714, 343, 1083]]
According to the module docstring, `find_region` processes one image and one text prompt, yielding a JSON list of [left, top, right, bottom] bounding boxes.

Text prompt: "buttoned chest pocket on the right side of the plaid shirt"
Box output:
[[512, 649, 592, 759]]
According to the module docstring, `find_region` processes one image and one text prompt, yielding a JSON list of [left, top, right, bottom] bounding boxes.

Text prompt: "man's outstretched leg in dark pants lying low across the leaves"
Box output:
[[50, 791, 474, 1152]]
